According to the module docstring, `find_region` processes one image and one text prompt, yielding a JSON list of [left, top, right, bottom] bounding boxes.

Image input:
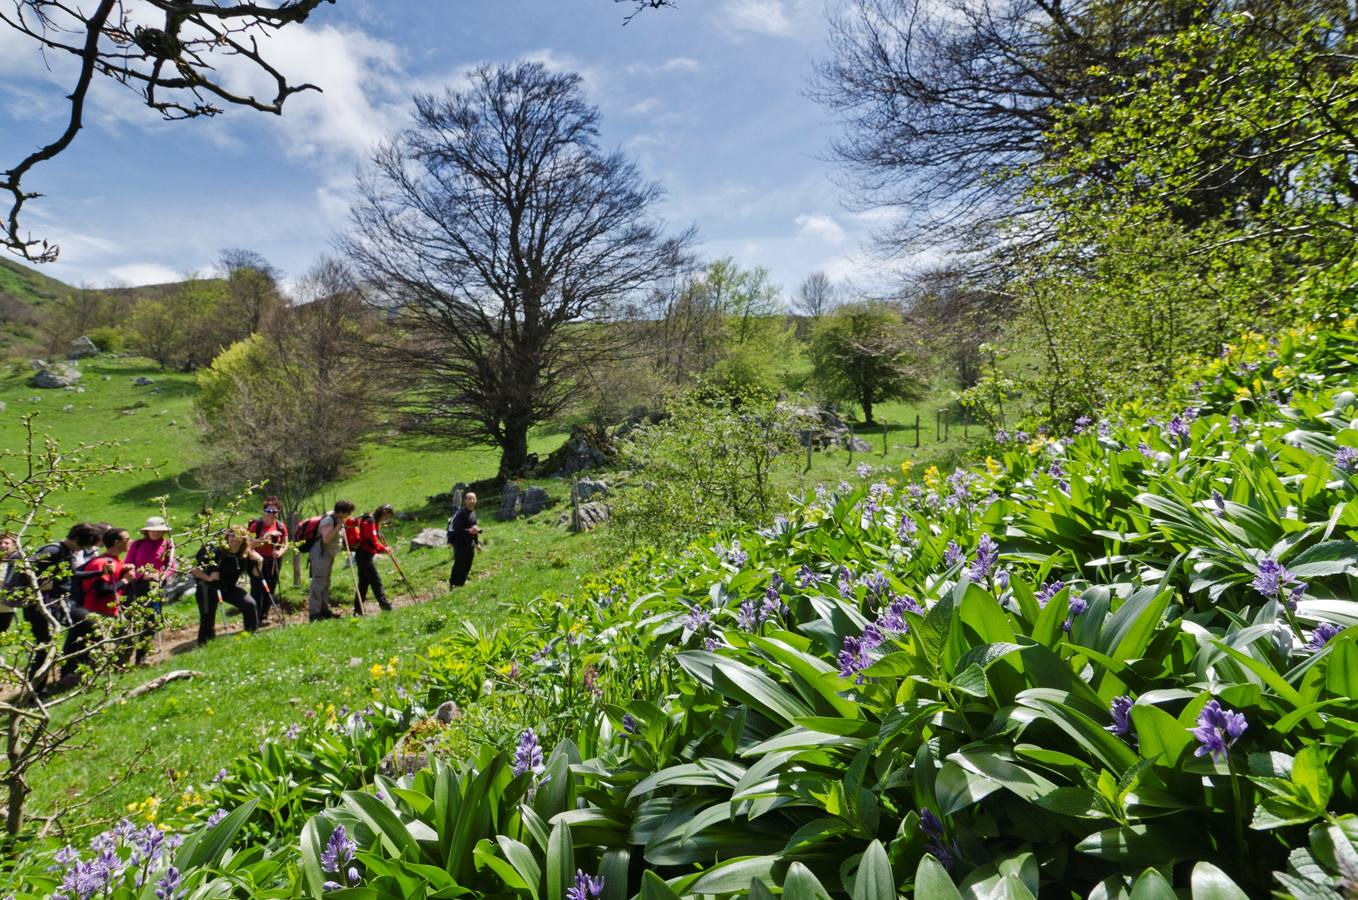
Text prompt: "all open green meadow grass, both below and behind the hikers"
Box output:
[[0, 357, 979, 820]]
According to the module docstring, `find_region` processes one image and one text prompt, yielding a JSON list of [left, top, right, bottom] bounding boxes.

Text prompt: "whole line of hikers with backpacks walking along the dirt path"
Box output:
[[0, 493, 481, 691]]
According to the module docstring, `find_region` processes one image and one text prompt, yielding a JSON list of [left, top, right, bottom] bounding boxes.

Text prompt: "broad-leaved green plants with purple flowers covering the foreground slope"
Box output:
[[7, 323, 1358, 899]]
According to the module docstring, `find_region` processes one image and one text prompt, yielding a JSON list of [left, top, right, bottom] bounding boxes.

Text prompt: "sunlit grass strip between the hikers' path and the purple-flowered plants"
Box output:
[[30, 509, 599, 820]]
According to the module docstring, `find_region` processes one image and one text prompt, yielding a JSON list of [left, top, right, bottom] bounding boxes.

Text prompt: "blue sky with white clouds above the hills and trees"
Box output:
[[0, 0, 875, 302]]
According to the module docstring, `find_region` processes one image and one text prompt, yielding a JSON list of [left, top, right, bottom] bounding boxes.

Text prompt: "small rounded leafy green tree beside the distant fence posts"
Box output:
[[811, 301, 925, 425]]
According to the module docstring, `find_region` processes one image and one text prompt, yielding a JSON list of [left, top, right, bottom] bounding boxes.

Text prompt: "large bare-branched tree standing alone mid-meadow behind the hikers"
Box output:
[[345, 64, 691, 476]]
